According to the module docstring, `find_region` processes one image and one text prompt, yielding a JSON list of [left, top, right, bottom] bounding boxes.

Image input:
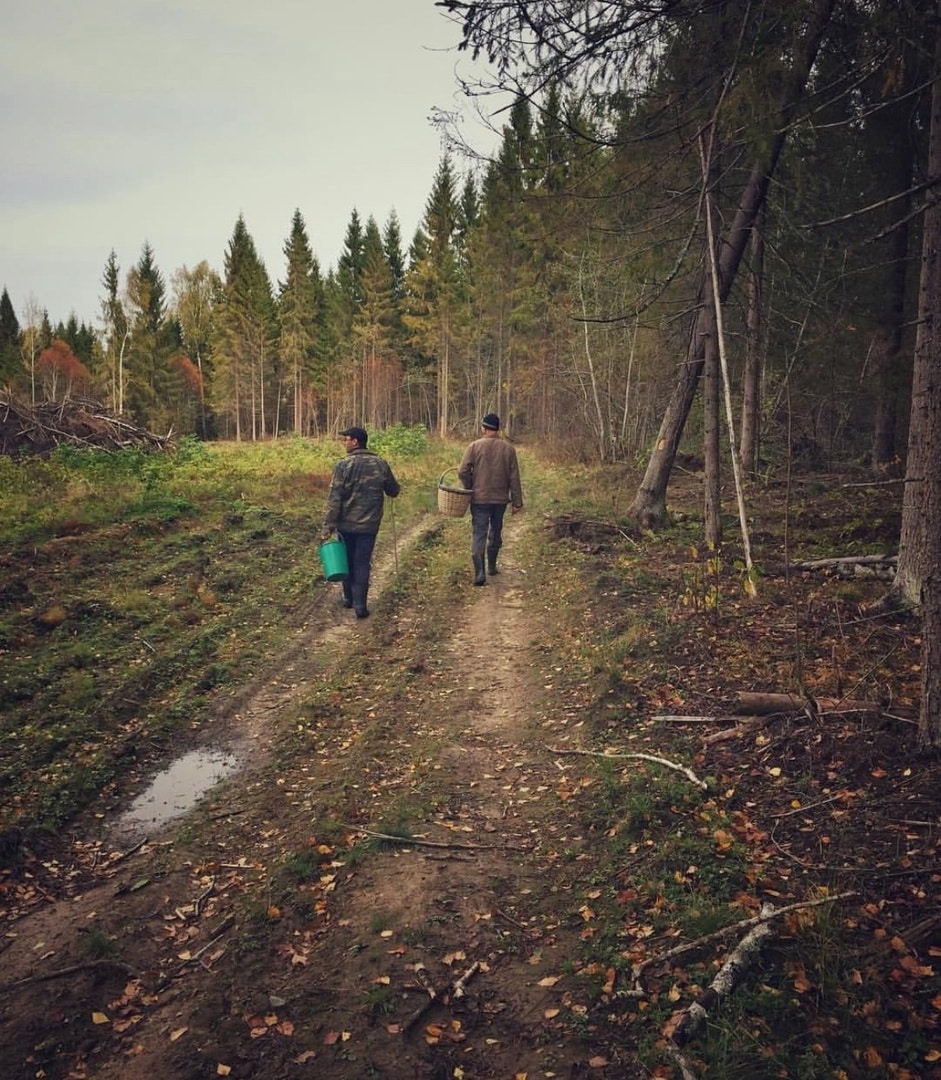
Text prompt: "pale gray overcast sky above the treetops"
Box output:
[[0, 0, 502, 326]]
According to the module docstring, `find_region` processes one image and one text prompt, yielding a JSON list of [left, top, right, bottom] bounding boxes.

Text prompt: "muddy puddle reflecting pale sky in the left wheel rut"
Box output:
[[111, 748, 244, 839]]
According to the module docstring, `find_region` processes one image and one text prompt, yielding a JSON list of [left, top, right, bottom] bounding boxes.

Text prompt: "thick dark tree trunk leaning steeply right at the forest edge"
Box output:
[[629, 0, 835, 526]]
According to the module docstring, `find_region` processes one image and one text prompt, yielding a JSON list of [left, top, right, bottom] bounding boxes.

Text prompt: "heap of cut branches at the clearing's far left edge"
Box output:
[[0, 393, 172, 455]]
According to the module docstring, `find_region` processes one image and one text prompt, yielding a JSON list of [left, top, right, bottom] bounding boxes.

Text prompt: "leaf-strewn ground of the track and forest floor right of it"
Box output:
[[0, 464, 941, 1080]]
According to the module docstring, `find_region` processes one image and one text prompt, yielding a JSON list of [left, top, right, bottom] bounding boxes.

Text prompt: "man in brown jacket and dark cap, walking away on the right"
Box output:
[[457, 413, 523, 585]]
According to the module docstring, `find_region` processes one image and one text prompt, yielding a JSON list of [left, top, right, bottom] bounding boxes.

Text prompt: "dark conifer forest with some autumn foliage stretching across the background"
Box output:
[[0, 0, 935, 469]]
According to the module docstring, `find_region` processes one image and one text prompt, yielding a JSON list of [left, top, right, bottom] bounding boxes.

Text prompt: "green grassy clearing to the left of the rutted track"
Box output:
[[0, 427, 440, 838]]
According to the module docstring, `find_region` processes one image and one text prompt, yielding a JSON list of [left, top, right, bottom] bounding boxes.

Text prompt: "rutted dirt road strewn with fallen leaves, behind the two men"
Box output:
[[0, 518, 624, 1080]]
